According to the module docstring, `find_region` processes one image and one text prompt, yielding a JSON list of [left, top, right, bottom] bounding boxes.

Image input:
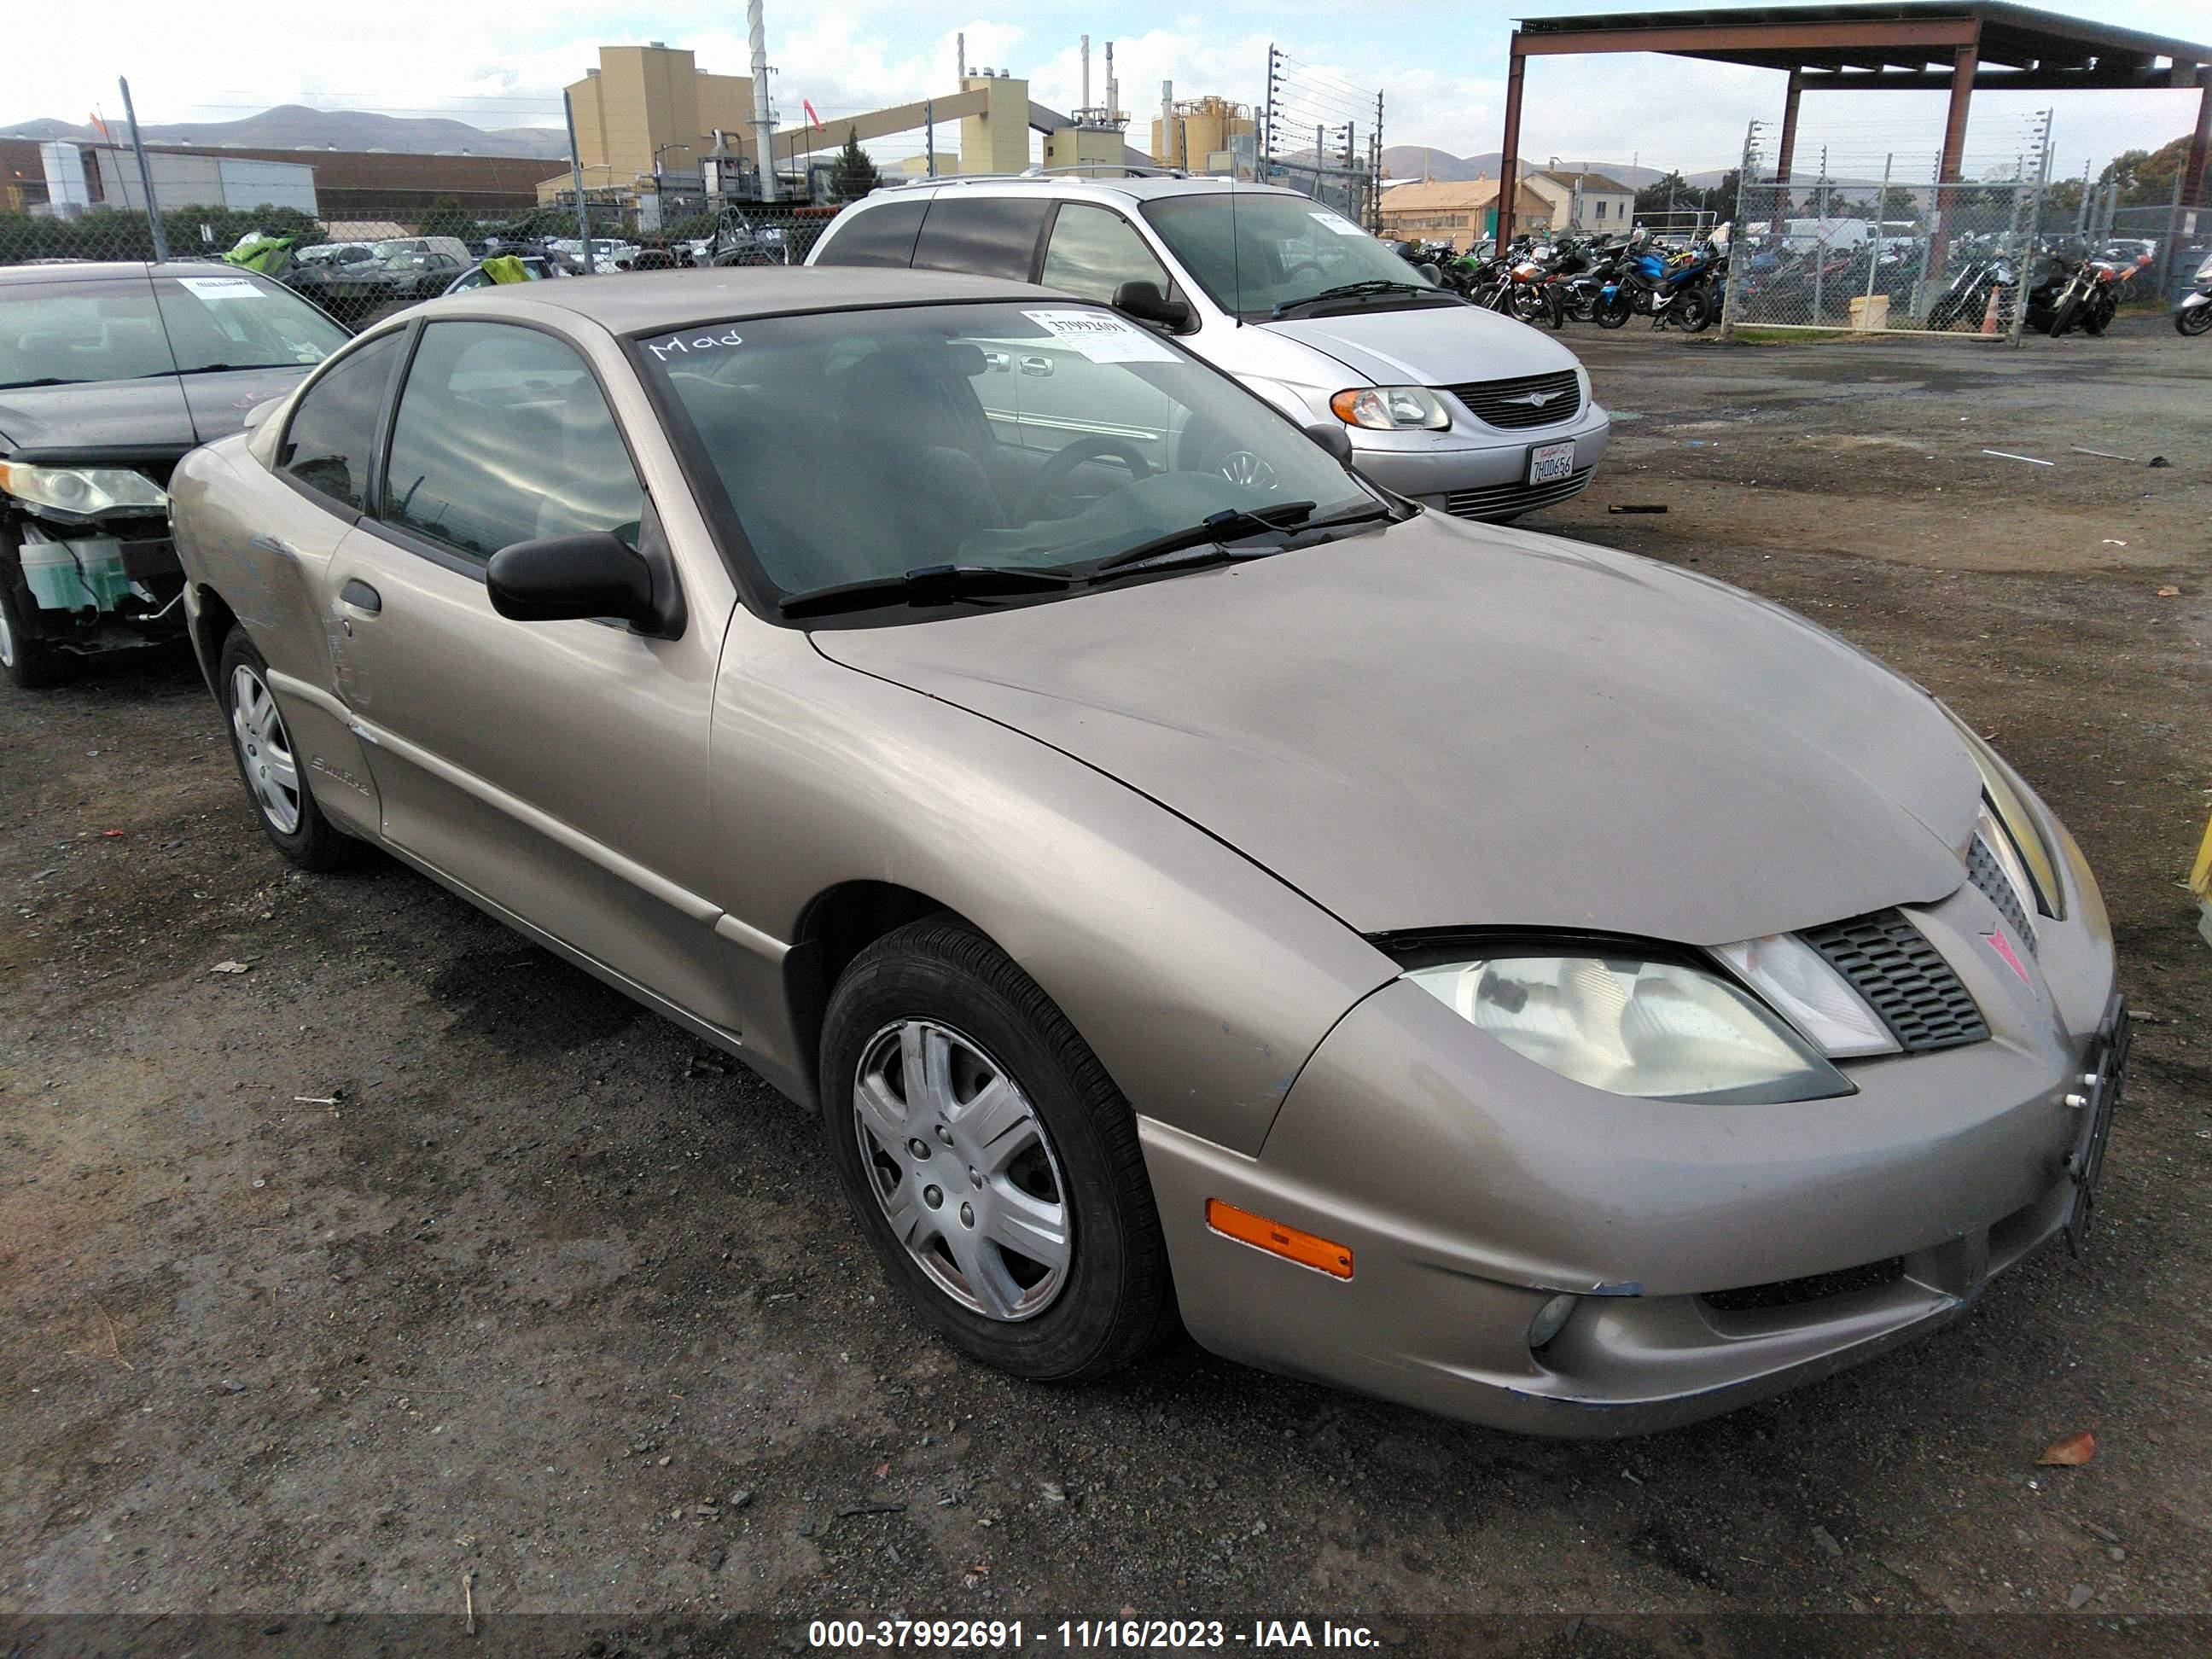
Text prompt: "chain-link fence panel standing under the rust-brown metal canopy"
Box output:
[[1723, 115, 2051, 343]]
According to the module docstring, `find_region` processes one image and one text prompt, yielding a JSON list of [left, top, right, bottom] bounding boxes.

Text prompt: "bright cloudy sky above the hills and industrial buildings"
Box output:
[[0, 0, 2212, 175]]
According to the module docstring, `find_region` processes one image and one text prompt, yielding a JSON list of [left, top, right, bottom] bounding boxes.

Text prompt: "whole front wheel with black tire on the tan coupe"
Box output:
[[821, 918, 1174, 1382]]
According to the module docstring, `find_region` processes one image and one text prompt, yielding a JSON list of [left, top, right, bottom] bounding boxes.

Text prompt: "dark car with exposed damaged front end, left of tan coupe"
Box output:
[[0, 263, 345, 686]]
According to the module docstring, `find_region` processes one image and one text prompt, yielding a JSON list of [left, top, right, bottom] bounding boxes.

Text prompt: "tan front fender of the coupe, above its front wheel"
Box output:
[[713, 617, 1394, 1152]]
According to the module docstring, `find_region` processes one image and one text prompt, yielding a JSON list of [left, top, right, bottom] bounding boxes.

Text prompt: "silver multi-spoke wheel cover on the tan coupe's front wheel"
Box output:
[[852, 1020, 1075, 1325]]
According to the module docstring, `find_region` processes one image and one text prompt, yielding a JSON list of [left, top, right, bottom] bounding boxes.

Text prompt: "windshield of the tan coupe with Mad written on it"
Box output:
[[635, 299, 1385, 619]]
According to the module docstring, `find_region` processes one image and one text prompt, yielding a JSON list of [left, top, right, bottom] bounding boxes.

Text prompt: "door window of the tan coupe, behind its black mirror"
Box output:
[[382, 323, 646, 562]]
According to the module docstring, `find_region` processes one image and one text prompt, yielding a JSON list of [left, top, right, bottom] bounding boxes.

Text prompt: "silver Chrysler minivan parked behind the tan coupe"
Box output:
[[807, 175, 1610, 520]]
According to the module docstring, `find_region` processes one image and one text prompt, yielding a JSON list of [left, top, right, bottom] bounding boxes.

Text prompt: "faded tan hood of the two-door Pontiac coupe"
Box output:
[[814, 515, 1980, 945]]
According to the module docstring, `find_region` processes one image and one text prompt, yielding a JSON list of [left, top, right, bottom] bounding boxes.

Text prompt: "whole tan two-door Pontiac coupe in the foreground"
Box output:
[[175, 266, 2128, 1435]]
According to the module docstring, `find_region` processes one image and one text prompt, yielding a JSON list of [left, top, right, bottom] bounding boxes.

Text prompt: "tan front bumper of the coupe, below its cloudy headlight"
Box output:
[[1141, 889, 2123, 1435]]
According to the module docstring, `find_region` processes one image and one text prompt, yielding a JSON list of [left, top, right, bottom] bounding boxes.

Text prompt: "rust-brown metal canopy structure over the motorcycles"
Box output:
[[1498, 0, 2212, 247]]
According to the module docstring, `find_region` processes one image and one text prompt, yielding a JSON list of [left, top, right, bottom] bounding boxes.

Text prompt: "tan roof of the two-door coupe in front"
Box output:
[[439, 265, 1077, 334]]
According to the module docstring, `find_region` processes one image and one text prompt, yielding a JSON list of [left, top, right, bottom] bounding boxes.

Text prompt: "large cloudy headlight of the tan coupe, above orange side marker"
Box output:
[[1407, 956, 1852, 1103]]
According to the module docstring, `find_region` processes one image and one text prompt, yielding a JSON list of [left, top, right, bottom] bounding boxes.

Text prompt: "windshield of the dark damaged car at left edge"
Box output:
[[0, 272, 345, 387]]
